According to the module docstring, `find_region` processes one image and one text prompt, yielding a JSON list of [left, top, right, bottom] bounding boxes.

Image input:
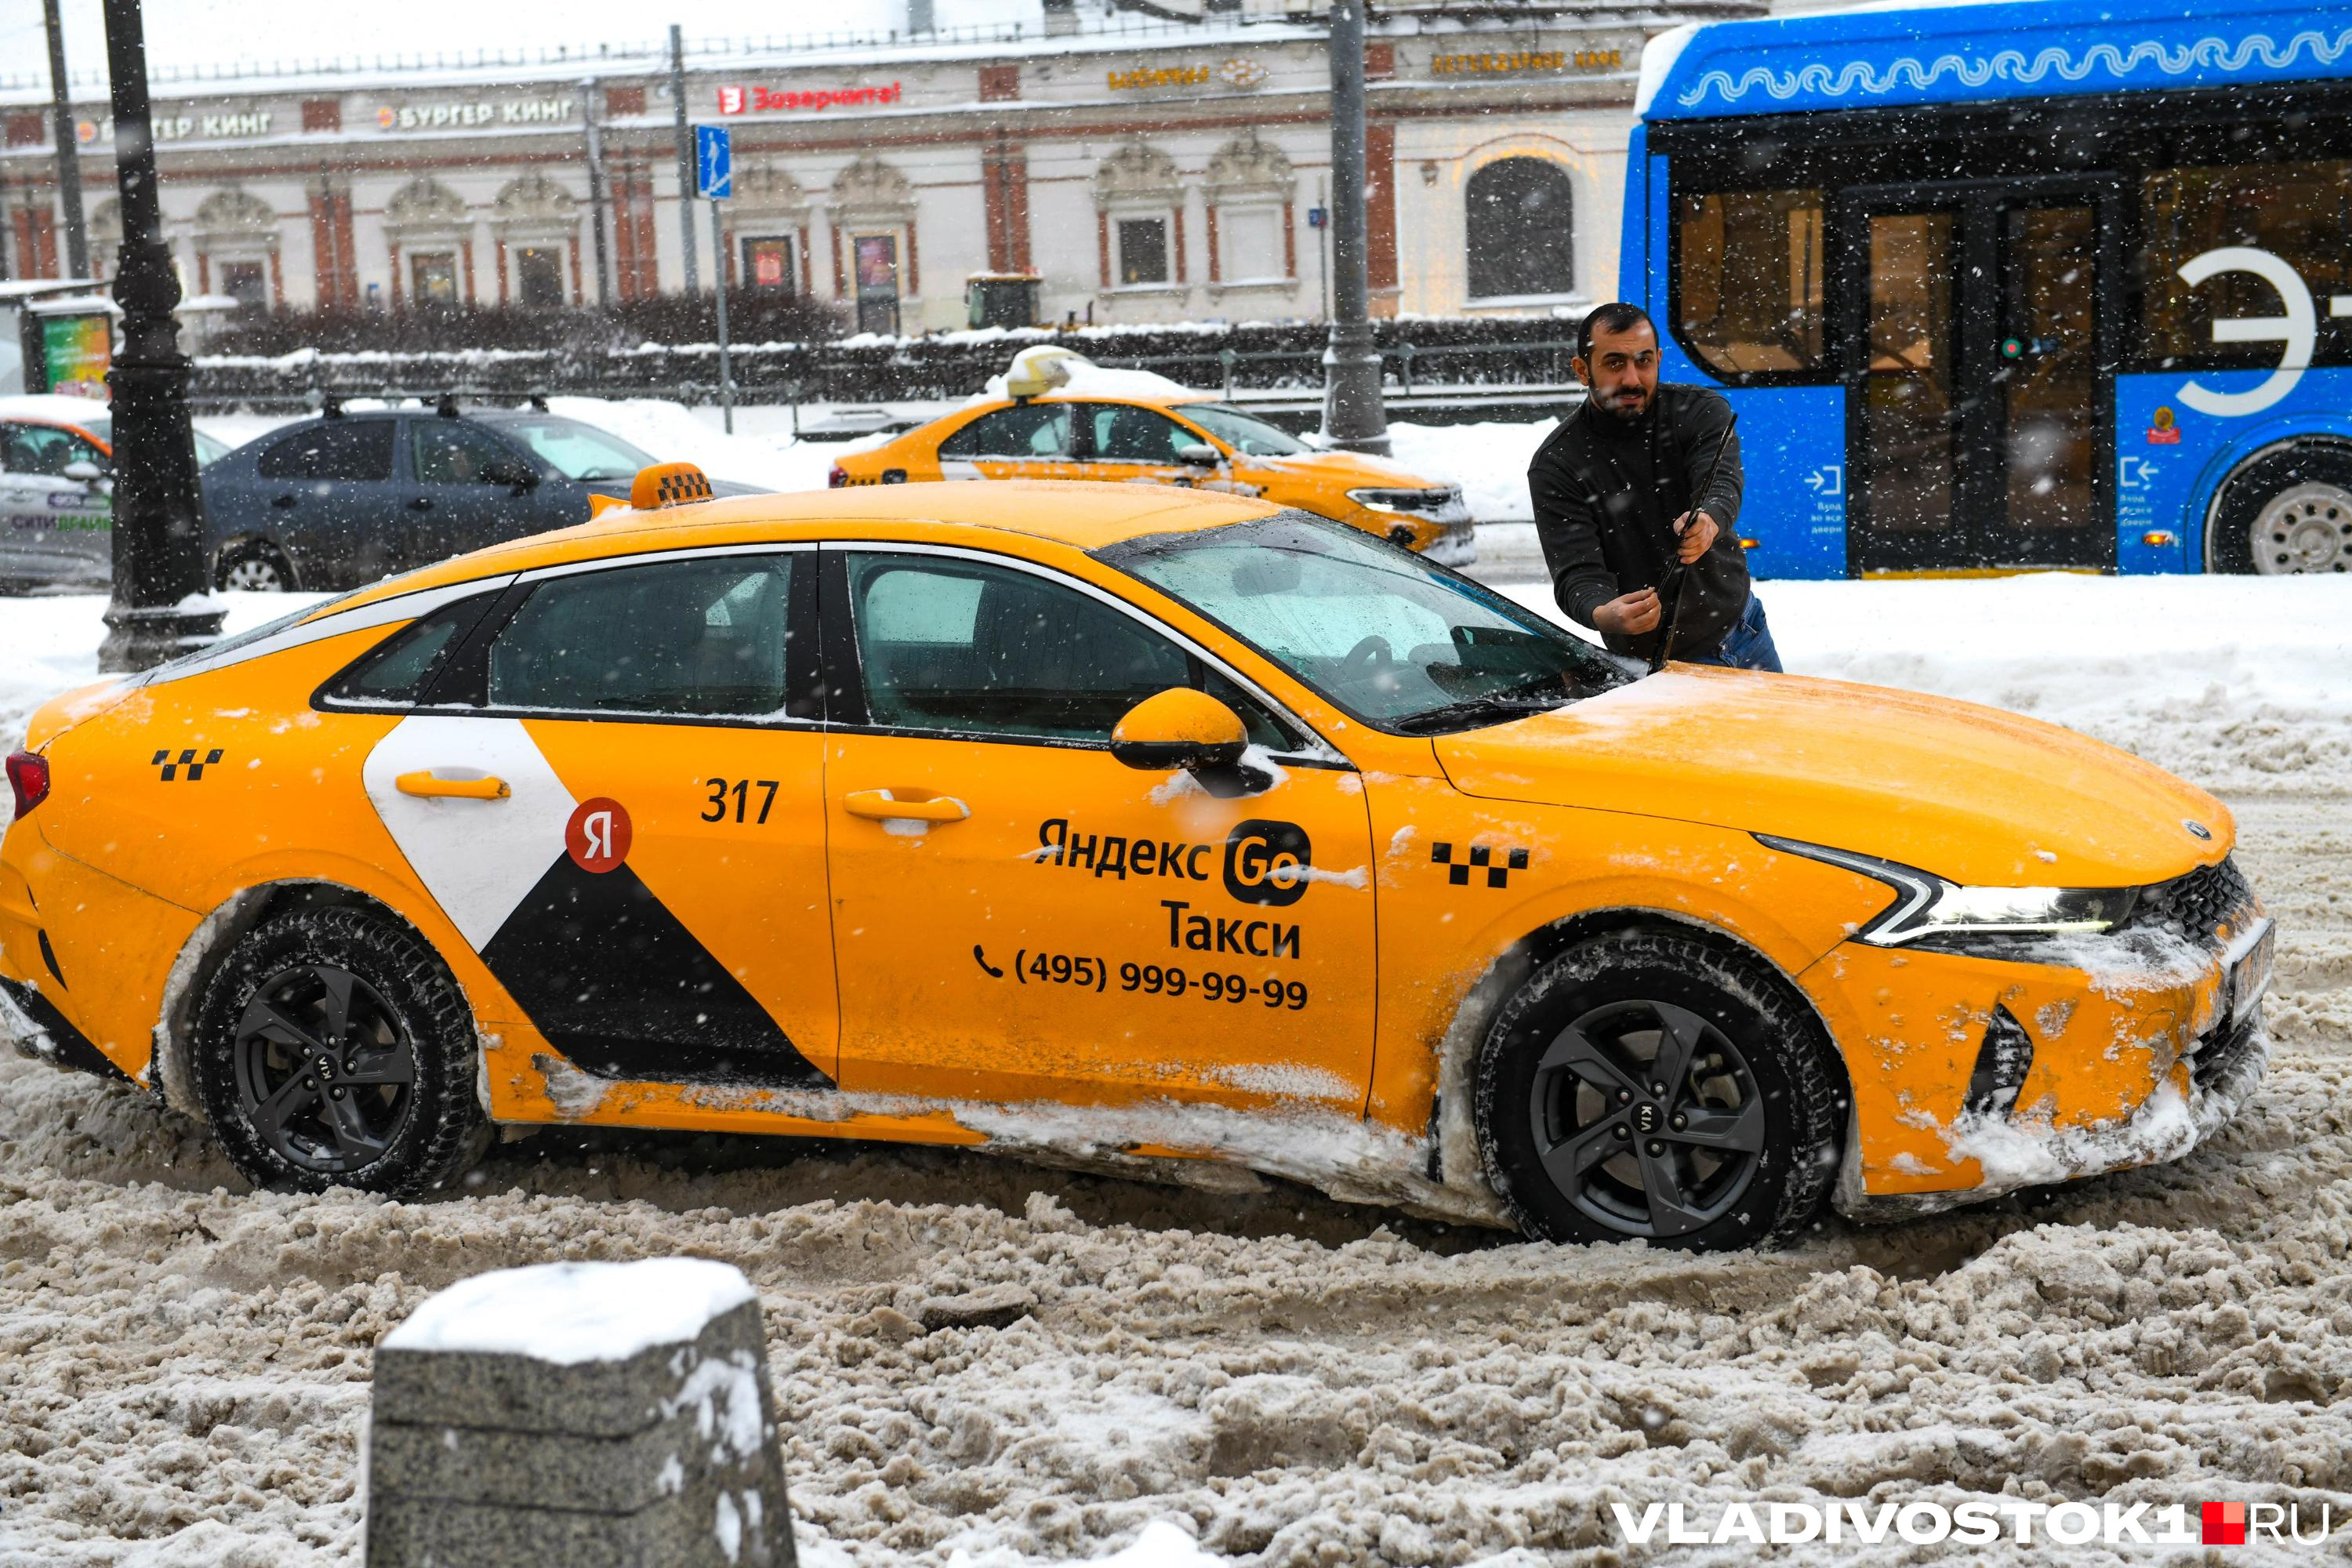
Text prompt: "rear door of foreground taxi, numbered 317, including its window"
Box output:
[[355, 548, 837, 1086]]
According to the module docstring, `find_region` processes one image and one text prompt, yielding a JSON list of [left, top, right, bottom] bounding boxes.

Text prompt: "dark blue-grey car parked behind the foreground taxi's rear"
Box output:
[[205, 400, 760, 590]]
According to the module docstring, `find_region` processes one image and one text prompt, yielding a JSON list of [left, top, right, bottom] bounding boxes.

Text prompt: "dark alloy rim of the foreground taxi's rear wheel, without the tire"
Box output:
[[235, 964, 416, 1175]]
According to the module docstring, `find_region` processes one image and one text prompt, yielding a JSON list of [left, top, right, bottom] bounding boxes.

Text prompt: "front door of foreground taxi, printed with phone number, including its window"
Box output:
[[823, 546, 1376, 1114]]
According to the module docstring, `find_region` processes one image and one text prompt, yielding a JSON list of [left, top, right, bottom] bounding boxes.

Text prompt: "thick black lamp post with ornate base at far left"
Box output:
[[99, 0, 221, 673]]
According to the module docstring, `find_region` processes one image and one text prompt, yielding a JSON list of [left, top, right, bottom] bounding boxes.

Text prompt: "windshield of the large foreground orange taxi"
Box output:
[[1096, 513, 1639, 736]]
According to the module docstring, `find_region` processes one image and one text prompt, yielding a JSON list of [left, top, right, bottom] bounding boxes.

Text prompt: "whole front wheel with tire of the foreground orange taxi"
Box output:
[[1475, 931, 1846, 1253]]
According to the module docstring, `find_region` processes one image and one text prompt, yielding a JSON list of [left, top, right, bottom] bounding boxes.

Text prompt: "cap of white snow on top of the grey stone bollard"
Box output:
[[383, 1258, 760, 1363]]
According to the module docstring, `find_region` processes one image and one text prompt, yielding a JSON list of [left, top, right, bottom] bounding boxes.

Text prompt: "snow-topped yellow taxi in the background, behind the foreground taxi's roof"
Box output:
[[828, 346, 1477, 567]]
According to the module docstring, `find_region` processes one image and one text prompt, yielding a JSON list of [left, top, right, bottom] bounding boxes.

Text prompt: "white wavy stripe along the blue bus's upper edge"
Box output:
[[1679, 28, 2352, 108]]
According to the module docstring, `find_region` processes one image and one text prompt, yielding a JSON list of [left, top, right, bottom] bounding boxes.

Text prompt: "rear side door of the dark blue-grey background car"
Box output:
[[242, 416, 412, 588]]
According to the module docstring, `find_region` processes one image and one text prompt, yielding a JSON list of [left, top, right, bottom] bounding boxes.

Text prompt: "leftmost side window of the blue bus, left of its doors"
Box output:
[[1675, 191, 1825, 376]]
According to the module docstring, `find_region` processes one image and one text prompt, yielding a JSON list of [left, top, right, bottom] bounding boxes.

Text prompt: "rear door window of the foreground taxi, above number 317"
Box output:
[[487, 555, 795, 720]]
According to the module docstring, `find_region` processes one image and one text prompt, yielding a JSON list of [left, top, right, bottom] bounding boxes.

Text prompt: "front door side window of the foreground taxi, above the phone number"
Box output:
[[849, 553, 1296, 750]]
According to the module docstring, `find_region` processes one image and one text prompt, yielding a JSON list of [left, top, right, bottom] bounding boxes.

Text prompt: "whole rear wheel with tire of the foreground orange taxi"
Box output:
[[195, 907, 489, 1196]]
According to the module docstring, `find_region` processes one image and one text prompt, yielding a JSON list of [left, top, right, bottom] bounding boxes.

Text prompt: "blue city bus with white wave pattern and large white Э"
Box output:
[[1623, 0, 2352, 579]]
